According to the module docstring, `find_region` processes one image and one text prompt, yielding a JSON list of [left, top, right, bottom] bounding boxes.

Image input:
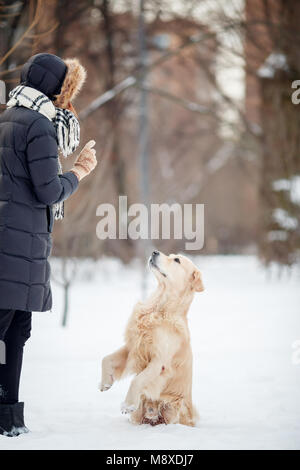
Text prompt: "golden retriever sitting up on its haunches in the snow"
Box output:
[[100, 251, 204, 426]]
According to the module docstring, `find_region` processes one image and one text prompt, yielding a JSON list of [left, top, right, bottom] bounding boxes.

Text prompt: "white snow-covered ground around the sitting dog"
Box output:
[[0, 256, 300, 450]]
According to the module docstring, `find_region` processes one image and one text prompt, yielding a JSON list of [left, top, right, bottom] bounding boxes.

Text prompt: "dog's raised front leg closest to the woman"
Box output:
[[99, 346, 128, 392]]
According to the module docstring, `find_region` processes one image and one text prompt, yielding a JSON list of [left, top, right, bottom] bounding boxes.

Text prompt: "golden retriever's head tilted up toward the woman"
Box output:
[[149, 251, 204, 294]]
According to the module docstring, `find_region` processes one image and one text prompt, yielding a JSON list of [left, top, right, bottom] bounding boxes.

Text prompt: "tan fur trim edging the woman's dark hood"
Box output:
[[54, 59, 86, 109]]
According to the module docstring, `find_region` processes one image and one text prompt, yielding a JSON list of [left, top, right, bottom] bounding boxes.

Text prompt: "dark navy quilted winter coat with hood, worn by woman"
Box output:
[[0, 54, 78, 312]]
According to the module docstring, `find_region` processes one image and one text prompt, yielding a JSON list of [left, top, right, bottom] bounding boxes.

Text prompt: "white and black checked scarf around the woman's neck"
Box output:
[[7, 85, 80, 220]]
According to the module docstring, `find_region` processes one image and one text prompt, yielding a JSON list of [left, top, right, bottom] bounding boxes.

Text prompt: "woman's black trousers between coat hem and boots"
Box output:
[[0, 310, 31, 405]]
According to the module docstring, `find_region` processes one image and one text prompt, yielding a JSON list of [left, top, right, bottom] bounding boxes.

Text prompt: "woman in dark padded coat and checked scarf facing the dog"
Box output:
[[0, 54, 97, 436]]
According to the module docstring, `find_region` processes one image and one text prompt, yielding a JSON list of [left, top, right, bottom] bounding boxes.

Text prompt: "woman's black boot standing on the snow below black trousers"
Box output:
[[0, 402, 29, 437]]
